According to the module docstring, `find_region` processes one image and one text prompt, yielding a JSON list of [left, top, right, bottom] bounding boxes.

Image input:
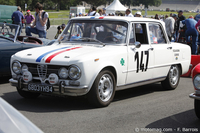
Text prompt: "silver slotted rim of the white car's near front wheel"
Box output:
[[98, 74, 113, 102]]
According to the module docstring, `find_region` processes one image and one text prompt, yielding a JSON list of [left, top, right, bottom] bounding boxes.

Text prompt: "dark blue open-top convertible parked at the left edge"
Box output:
[[0, 23, 52, 76]]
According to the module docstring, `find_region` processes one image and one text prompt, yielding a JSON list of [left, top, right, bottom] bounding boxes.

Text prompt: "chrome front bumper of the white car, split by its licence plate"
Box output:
[[9, 78, 88, 96]]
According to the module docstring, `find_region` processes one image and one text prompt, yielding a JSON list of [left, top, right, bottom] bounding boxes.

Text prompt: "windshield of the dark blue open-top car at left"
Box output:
[[0, 23, 18, 40]]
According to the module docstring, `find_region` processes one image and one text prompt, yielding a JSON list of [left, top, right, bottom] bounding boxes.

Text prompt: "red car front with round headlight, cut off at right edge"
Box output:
[[189, 63, 200, 119]]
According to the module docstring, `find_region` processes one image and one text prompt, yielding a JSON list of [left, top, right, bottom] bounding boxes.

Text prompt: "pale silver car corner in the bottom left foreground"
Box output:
[[0, 97, 43, 133]]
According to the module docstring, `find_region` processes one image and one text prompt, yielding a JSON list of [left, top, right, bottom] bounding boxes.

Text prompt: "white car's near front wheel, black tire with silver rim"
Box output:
[[87, 70, 116, 107]]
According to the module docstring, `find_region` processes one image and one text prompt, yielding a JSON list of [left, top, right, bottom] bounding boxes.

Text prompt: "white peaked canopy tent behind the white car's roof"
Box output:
[[106, 0, 127, 13]]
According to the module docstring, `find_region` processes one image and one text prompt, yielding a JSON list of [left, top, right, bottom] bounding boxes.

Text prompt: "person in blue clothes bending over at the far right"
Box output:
[[182, 16, 199, 54]]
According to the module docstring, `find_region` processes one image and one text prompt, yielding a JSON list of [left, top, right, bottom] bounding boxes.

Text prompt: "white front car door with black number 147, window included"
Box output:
[[126, 23, 154, 84]]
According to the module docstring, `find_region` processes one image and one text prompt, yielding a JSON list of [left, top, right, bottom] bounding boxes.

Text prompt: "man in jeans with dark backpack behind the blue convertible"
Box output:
[[26, 2, 49, 38]]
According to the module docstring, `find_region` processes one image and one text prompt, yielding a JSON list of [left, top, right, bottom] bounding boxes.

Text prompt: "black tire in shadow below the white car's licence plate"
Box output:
[[17, 87, 40, 99]]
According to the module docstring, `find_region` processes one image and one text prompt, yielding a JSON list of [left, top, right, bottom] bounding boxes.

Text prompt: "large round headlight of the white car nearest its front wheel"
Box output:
[[69, 66, 81, 80]]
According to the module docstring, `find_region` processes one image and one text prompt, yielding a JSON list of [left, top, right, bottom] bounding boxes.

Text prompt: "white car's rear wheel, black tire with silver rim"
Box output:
[[161, 65, 181, 90]]
